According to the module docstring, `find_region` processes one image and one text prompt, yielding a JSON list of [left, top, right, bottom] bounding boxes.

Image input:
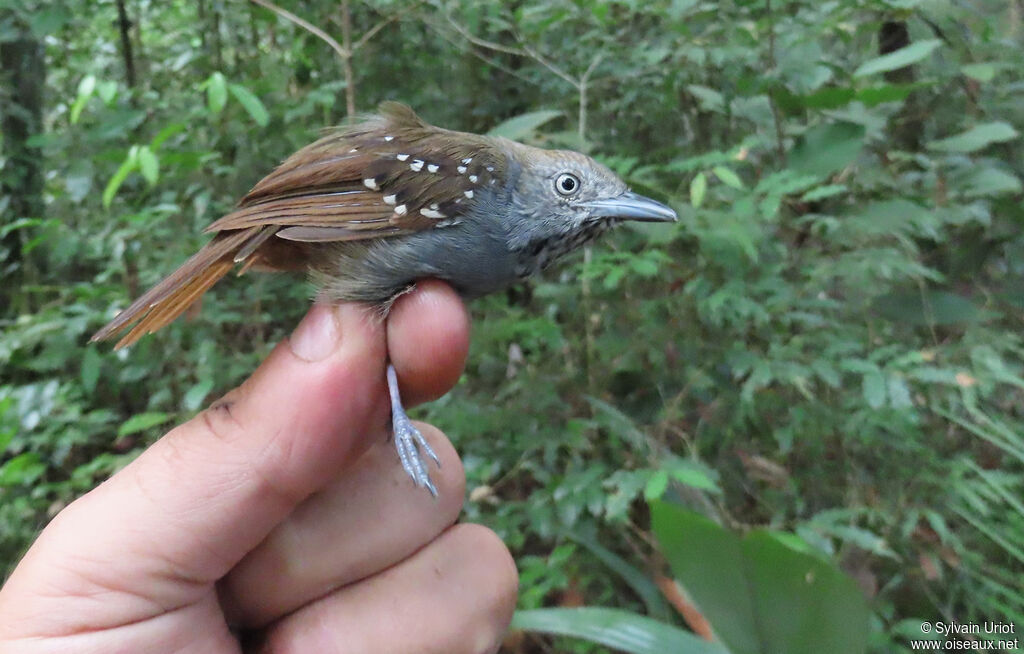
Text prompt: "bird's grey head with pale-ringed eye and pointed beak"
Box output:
[[501, 144, 678, 247]]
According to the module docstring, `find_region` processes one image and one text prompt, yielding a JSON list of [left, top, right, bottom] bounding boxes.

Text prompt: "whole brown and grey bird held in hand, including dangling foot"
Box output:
[[90, 101, 678, 496]]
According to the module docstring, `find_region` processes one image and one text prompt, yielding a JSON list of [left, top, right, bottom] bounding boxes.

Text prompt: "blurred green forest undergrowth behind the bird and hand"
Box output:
[[0, 0, 1024, 652]]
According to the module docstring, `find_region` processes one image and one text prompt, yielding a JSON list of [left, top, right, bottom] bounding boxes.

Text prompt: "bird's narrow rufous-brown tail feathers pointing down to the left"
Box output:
[[89, 227, 275, 348]]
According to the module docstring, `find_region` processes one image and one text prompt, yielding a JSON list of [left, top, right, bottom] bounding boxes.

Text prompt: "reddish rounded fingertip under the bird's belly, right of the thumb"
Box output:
[[387, 279, 469, 408]]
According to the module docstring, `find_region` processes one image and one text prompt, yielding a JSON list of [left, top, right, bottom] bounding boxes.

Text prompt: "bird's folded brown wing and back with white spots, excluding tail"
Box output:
[[207, 102, 507, 242]]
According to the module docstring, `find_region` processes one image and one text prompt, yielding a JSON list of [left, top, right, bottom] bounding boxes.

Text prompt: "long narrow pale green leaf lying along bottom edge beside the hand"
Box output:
[[510, 607, 729, 654]]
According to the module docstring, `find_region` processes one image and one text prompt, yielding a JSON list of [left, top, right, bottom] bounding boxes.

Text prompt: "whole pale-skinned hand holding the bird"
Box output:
[[0, 281, 517, 654]]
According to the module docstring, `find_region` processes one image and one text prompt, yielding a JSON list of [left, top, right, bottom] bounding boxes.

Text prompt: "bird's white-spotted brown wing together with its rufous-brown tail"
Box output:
[[92, 102, 507, 348]]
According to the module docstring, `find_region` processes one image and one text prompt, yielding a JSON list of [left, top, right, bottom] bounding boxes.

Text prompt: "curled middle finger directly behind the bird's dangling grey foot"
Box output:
[[220, 424, 466, 627]]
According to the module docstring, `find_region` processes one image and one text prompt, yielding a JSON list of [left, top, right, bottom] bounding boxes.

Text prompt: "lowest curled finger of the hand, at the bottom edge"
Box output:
[[264, 524, 517, 654]]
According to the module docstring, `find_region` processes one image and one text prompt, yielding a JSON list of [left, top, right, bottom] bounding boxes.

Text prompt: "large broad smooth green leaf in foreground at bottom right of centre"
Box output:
[[651, 502, 868, 654]]
